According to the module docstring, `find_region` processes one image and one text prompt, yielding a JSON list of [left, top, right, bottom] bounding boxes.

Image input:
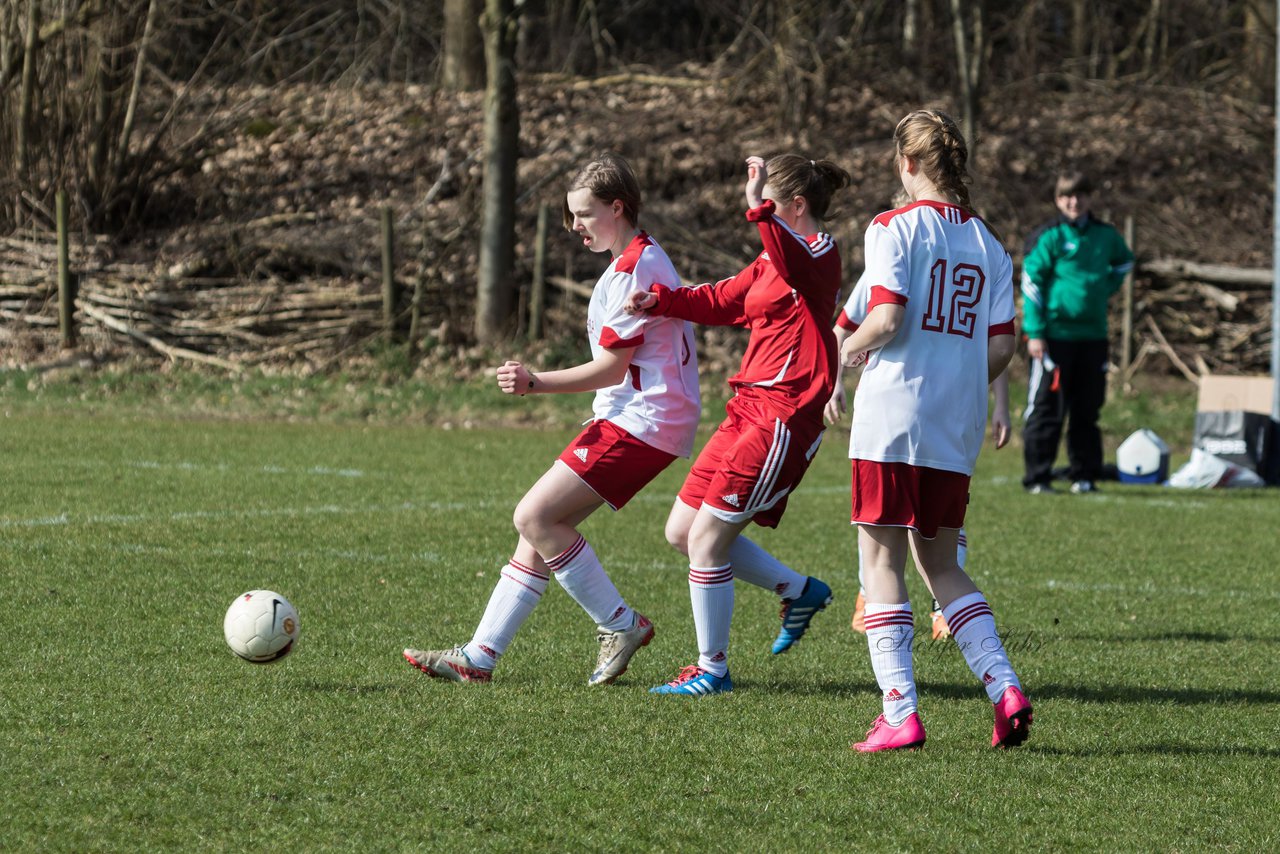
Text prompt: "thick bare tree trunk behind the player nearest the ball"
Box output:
[[475, 0, 520, 343]]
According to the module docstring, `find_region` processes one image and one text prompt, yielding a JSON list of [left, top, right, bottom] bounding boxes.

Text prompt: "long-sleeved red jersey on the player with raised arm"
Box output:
[[649, 200, 840, 424]]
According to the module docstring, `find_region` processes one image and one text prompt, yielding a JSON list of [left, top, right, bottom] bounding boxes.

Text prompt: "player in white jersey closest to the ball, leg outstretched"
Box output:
[[404, 154, 700, 685]]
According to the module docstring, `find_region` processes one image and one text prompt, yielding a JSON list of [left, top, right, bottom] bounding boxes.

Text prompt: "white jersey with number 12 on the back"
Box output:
[[846, 201, 1014, 475]]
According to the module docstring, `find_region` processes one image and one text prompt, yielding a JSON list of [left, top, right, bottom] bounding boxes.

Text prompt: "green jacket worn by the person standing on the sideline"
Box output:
[[1021, 216, 1133, 341]]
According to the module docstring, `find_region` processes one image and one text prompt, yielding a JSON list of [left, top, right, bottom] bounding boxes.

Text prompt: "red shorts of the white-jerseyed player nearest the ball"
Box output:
[[559, 420, 676, 510]]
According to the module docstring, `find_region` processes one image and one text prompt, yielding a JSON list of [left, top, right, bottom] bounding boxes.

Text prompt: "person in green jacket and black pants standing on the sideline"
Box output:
[[1021, 172, 1133, 493]]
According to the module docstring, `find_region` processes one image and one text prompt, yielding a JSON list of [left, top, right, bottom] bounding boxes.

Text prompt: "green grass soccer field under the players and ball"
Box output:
[[0, 376, 1280, 851]]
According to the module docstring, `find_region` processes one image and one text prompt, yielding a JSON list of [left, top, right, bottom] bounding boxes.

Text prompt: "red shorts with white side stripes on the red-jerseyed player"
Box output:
[[680, 397, 823, 528]]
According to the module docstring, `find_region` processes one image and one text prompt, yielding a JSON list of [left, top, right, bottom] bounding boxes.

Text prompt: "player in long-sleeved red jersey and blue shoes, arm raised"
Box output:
[[630, 155, 849, 695]]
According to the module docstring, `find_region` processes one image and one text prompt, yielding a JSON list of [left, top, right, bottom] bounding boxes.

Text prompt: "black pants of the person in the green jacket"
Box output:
[[1023, 338, 1107, 487]]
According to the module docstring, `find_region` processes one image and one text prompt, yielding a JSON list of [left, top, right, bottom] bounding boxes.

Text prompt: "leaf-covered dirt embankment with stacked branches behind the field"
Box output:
[[0, 69, 1274, 373]]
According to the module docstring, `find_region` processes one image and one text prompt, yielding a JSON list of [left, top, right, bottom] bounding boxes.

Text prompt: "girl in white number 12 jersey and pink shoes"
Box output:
[[841, 110, 1032, 753]]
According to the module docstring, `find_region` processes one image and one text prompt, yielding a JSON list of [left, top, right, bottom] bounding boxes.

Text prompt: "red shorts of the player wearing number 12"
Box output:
[[850, 460, 969, 539]]
